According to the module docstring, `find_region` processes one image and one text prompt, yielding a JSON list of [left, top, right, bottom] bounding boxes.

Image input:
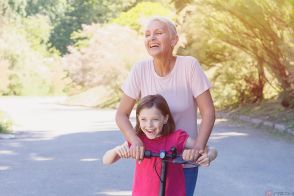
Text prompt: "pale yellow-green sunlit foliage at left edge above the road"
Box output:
[[0, 20, 64, 95]]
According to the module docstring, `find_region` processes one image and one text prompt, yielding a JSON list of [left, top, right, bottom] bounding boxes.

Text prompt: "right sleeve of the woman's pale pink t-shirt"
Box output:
[[190, 58, 211, 97]]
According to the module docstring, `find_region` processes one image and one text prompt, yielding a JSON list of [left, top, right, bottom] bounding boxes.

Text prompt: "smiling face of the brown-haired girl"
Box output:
[[138, 106, 168, 139]]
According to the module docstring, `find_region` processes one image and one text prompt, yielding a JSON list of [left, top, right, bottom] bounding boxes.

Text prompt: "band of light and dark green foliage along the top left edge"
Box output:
[[0, 0, 137, 54]]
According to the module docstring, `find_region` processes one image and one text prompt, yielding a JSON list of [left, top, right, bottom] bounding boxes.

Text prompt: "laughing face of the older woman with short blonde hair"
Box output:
[[145, 20, 172, 57]]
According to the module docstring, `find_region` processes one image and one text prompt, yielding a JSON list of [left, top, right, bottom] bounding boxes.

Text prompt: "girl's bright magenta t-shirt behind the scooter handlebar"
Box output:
[[132, 130, 189, 196]]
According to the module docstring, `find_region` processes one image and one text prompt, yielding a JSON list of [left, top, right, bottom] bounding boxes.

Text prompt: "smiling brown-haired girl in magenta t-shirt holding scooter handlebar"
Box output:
[[103, 95, 217, 196]]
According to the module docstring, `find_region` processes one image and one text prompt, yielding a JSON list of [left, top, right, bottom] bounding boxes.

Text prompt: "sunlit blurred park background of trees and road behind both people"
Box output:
[[0, 0, 294, 196]]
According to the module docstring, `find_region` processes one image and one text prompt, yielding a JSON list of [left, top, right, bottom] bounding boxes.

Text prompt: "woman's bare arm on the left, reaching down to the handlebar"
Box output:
[[115, 94, 144, 160]]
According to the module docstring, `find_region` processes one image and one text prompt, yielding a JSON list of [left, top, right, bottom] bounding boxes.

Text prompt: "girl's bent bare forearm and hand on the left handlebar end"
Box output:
[[102, 142, 130, 165]]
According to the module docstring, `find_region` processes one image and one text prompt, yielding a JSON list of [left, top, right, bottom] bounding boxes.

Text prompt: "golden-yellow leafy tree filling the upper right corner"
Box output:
[[176, 0, 294, 107]]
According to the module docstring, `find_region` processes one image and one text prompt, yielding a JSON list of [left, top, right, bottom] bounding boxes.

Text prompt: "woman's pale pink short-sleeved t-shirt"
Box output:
[[122, 56, 211, 139]]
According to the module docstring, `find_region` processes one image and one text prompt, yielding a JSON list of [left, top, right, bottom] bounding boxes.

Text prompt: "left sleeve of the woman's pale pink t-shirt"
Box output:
[[122, 64, 140, 100]]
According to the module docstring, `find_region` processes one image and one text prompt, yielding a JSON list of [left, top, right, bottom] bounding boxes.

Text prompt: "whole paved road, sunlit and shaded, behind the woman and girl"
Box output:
[[0, 97, 294, 196]]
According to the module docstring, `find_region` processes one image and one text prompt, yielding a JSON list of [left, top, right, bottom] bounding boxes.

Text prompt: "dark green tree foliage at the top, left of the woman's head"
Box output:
[[50, 0, 135, 54]]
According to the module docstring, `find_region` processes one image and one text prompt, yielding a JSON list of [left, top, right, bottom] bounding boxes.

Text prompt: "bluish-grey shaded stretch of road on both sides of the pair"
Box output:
[[0, 120, 294, 196]]
